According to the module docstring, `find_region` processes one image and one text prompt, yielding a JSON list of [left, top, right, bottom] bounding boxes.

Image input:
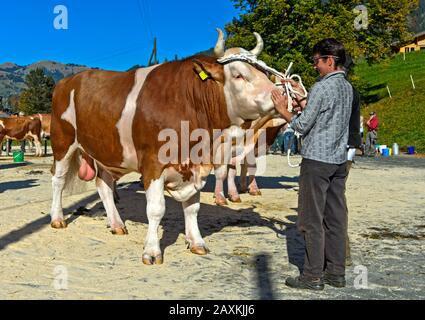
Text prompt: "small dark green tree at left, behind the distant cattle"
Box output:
[[18, 69, 55, 114]]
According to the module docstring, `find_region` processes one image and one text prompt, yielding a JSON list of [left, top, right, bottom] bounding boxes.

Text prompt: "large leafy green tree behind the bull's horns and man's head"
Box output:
[[226, 0, 419, 85]]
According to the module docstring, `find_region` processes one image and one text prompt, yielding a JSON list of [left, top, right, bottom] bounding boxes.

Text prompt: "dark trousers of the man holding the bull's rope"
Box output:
[[297, 158, 347, 278]]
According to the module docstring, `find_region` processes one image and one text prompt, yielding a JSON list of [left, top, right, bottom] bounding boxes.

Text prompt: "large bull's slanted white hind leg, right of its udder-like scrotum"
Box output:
[[96, 168, 128, 235]]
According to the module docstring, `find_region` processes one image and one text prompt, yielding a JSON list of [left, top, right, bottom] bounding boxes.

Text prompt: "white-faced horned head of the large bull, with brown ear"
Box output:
[[194, 29, 276, 125]]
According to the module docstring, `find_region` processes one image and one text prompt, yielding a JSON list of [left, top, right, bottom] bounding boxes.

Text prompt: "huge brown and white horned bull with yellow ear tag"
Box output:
[[51, 31, 275, 264]]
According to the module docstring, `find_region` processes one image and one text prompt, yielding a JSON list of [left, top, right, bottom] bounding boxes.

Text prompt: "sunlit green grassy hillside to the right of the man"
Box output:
[[355, 51, 425, 153]]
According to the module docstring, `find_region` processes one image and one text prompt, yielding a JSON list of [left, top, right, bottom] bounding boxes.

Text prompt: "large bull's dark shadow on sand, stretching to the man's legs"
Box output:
[[78, 181, 304, 268]]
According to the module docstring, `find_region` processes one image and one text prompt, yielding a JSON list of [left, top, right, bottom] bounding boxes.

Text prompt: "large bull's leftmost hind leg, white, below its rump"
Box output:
[[50, 143, 77, 229]]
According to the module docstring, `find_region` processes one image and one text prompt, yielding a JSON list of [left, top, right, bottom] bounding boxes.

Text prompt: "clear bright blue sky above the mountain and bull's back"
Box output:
[[0, 0, 239, 70]]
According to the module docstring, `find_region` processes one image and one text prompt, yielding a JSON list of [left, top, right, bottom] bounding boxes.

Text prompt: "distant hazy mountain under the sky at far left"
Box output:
[[0, 60, 90, 98]]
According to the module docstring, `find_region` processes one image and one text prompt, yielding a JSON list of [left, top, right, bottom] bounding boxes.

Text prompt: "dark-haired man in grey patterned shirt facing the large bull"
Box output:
[[272, 39, 353, 290]]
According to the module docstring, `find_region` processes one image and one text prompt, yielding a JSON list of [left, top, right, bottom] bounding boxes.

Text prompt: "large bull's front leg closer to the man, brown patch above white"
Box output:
[[182, 192, 209, 255]]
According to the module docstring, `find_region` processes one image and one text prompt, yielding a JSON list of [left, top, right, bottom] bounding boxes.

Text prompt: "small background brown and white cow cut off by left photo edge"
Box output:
[[0, 116, 42, 157]]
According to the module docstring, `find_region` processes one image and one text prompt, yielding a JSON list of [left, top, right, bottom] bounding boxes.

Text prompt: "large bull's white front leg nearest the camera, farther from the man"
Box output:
[[142, 176, 165, 265]]
